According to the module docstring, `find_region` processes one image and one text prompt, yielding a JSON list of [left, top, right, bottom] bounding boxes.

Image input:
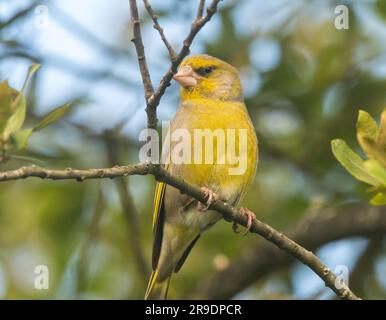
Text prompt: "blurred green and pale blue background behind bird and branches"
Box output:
[[0, 0, 386, 299]]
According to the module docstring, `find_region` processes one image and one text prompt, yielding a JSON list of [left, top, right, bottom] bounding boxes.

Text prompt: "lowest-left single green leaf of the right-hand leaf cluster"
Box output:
[[331, 139, 381, 187]]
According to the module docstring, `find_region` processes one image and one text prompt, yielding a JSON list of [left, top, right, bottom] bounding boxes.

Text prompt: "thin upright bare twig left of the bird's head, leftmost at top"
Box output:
[[129, 0, 154, 101]]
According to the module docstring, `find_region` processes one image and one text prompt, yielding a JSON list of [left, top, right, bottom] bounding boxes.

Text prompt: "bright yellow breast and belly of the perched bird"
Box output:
[[170, 101, 257, 200]]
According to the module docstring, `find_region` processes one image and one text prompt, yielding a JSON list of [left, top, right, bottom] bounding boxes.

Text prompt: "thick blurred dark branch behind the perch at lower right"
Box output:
[[189, 203, 386, 299]]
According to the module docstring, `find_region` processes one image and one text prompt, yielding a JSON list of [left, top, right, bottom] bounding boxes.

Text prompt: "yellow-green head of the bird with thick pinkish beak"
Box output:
[[173, 54, 243, 101]]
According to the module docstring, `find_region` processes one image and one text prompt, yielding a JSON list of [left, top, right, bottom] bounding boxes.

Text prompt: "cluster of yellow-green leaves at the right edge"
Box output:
[[331, 110, 386, 205]]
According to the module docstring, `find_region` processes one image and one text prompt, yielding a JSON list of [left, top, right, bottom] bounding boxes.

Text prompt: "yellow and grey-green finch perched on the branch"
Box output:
[[145, 54, 258, 300]]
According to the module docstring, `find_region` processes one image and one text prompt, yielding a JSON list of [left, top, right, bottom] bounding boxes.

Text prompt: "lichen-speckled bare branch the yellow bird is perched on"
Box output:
[[0, 164, 359, 300]]
